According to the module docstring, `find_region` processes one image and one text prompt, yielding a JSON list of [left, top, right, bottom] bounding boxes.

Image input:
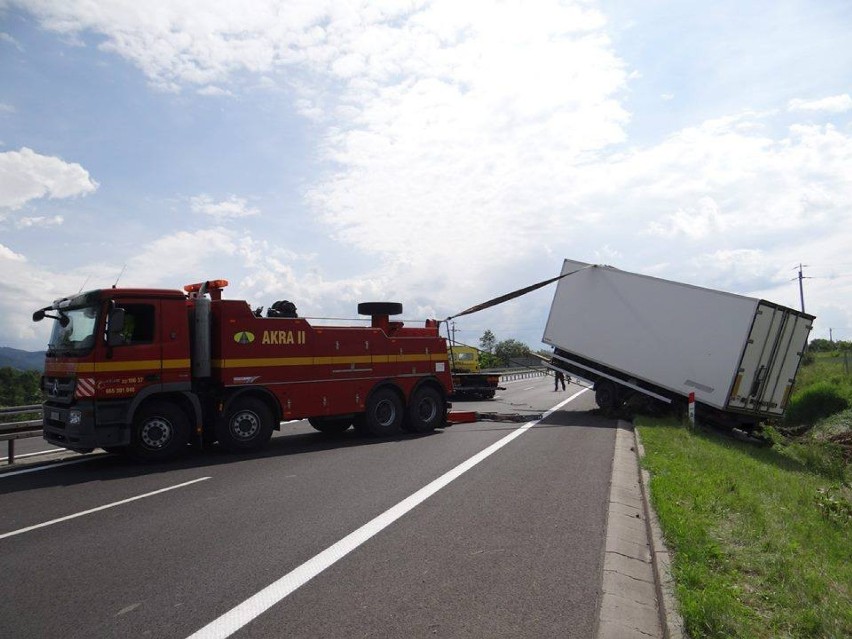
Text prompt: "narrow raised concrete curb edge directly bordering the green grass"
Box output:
[[632, 428, 688, 639]]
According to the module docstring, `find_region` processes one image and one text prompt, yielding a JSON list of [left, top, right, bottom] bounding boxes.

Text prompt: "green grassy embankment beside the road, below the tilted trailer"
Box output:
[[636, 354, 852, 639]]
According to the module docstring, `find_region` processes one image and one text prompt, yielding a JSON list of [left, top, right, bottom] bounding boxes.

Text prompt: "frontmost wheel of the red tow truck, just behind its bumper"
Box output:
[[129, 402, 190, 462]]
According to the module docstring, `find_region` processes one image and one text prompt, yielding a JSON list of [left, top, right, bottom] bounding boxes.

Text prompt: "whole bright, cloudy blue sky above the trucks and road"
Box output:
[[0, 0, 852, 350]]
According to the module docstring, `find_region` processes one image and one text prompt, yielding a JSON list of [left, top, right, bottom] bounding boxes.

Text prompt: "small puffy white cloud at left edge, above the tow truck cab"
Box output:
[[0, 147, 98, 210]]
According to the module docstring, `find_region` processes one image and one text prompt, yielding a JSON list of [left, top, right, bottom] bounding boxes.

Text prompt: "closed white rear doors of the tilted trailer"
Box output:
[[728, 300, 813, 416]]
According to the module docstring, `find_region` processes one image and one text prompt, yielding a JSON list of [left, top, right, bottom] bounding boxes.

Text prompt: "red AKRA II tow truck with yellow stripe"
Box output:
[[33, 280, 452, 461]]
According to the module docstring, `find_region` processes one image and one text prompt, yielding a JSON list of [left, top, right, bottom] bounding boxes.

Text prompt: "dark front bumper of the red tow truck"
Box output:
[[44, 402, 130, 452]]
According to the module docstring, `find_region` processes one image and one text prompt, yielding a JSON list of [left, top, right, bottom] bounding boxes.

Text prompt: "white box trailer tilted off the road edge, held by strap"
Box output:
[[542, 260, 814, 429]]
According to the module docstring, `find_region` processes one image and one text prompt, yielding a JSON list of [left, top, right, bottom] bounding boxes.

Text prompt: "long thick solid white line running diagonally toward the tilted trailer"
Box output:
[[189, 388, 588, 639]]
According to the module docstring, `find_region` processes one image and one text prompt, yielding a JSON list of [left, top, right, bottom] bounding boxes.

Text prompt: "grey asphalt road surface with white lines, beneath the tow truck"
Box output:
[[0, 378, 615, 638]]
